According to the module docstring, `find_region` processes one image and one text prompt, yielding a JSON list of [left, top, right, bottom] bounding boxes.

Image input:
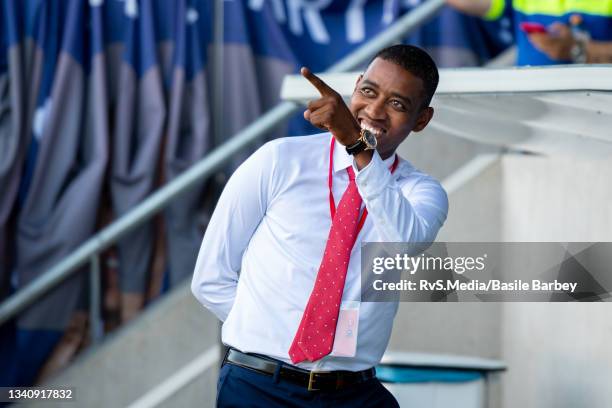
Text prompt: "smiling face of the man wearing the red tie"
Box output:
[[350, 58, 433, 159]]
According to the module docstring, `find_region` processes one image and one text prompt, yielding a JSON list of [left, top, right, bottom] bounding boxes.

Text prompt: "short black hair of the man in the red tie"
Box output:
[[370, 44, 440, 108]]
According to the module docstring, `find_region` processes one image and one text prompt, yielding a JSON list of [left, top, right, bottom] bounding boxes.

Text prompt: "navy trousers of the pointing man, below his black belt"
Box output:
[[217, 363, 399, 408]]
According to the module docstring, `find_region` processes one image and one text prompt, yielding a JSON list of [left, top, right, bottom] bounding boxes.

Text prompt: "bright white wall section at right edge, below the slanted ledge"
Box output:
[[501, 156, 612, 408]]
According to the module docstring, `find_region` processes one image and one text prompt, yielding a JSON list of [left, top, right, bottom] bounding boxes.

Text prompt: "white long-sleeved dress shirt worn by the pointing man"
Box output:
[[191, 133, 448, 371]]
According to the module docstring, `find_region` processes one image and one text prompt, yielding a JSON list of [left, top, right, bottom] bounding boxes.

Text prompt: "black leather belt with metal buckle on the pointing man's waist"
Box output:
[[223, 348, 376, 391]]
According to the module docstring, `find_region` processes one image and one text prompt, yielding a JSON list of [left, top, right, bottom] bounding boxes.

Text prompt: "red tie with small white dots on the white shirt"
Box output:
[[289, 167, 361, 364]]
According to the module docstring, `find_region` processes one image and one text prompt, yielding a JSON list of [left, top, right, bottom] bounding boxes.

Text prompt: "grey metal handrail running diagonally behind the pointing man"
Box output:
[[0, 0, 445, 342]]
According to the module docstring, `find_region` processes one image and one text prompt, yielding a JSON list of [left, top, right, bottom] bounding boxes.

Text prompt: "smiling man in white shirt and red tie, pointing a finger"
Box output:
[[191, 45, 448, 407]]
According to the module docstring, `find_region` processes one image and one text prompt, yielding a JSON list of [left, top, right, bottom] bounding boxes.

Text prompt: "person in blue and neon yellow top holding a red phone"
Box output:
[[447, 0, 612, 65]]
